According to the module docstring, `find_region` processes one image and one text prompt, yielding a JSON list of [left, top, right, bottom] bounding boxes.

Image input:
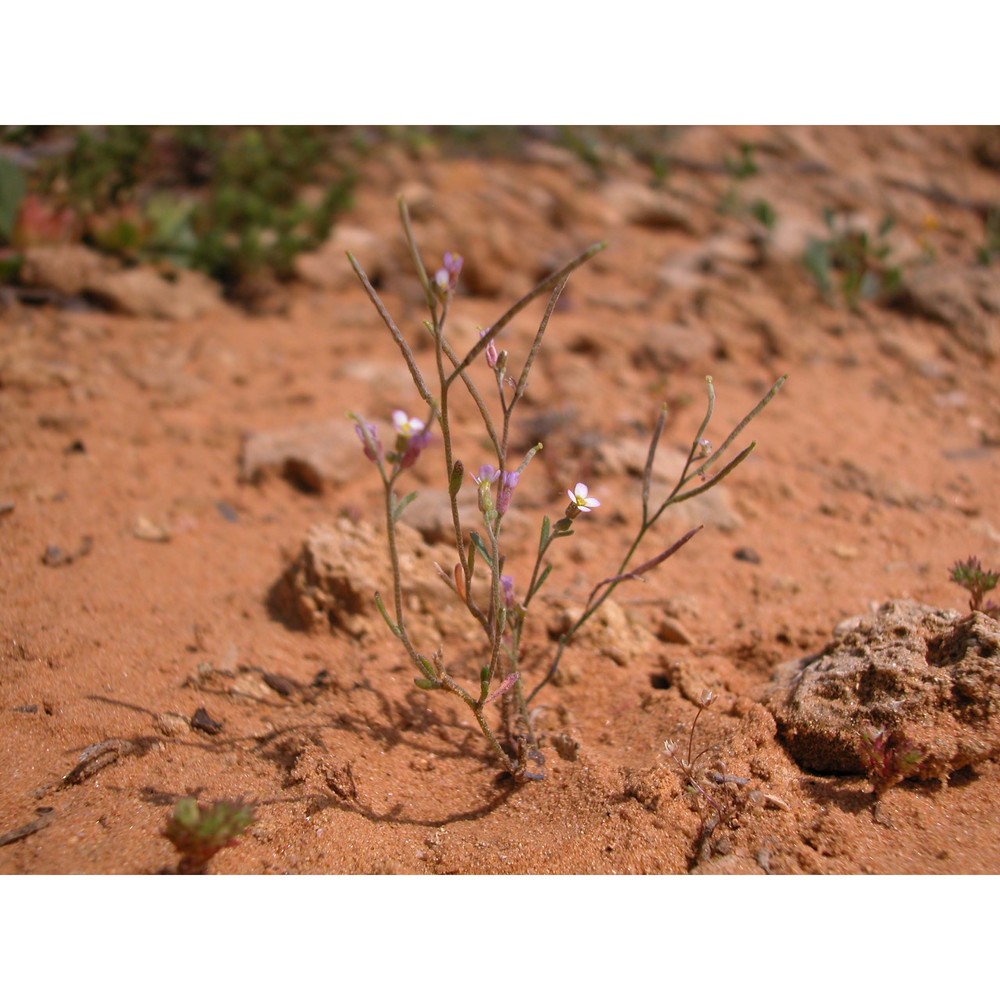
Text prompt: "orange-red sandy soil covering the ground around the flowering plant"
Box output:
[[0, 128, 1000, 874]]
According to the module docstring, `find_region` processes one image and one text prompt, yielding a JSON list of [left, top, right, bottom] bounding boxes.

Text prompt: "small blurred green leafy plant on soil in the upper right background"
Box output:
[[802, 208, 903, 310]]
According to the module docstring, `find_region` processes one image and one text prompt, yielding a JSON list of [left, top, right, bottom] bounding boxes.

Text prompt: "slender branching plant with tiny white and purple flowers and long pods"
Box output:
[[347, 199, 784, 782]]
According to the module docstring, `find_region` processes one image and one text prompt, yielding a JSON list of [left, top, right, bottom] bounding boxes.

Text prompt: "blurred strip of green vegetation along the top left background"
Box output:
[[0, 125, 666, 300]]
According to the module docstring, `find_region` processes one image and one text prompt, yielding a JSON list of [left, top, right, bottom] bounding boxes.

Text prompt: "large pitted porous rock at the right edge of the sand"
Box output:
[[765, 601, 1000, 778]]
